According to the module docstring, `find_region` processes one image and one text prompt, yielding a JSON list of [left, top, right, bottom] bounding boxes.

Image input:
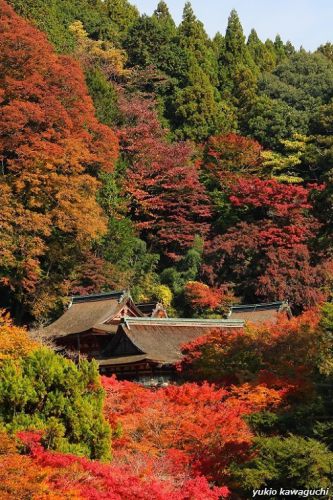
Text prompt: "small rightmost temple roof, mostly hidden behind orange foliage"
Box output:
[[229, 301, 291, 325]]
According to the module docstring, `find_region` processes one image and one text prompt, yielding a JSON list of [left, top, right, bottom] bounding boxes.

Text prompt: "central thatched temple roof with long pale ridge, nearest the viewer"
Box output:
[[99, 318, 244, 366]]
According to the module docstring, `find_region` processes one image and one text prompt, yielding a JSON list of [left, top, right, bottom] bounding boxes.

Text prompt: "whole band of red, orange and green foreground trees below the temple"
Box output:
[[0, 304, 333, 500]]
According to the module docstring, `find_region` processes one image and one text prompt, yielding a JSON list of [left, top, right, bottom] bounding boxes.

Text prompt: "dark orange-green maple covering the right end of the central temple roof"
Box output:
[[182, 309, 320, 390]]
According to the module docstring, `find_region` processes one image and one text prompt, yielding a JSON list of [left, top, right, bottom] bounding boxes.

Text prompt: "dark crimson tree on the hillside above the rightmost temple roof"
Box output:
[[205, 178, 327, 310]]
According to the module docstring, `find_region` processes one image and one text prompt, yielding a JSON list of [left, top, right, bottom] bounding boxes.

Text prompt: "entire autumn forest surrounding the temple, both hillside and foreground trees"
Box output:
[[0, 0, 333, 500]]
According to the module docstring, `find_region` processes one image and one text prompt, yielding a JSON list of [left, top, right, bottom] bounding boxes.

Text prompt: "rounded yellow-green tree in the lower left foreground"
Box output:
[[0, 348, 110, 458]]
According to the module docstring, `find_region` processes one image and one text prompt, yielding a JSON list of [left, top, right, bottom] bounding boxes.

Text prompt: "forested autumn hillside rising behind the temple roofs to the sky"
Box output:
[[0, 0, 333, 322]]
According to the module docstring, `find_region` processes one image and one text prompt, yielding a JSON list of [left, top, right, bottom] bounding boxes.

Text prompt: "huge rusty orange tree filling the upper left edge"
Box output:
[[0, 0, 118, 318]]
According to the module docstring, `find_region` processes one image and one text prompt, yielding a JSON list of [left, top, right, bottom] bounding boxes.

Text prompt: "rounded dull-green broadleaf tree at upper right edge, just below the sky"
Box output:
[[244, 51, 333, 150]]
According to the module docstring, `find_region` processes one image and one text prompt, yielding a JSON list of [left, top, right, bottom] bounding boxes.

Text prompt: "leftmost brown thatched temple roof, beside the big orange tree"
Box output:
[[44, 291, 142, 338]]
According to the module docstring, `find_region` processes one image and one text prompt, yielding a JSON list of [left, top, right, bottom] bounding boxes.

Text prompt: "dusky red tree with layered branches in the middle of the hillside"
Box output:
[[120, 97, 210, 260]]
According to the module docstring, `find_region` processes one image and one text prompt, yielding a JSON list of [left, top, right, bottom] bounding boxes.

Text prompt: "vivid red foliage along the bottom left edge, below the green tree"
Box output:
[[0, 432, 228, 500]]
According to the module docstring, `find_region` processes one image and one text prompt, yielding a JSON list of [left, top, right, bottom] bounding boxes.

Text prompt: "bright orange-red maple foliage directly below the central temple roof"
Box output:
[[102, 377, 284, 484]]
